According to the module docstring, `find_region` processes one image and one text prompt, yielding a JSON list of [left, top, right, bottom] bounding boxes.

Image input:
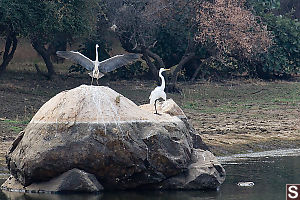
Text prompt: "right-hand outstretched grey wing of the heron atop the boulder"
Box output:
[[99, 53, 141, 73]]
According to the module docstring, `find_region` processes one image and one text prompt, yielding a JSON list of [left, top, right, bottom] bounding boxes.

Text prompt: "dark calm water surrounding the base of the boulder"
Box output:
[[0, 149, 300, 200]]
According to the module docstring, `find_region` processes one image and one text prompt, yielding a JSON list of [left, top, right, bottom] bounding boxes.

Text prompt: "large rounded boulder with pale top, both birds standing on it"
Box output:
[[2, 85, 225, 192]]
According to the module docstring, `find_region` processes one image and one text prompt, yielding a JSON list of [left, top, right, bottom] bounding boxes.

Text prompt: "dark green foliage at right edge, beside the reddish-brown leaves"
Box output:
[[249, 0, 300, 76]]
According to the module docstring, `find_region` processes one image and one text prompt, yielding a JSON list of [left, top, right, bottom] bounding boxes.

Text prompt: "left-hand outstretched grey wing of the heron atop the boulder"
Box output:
[[56, 51, 94, 71]]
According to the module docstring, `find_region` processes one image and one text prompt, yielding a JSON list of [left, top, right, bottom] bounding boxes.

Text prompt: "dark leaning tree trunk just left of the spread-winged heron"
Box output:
[[31, 41, 55, 79]]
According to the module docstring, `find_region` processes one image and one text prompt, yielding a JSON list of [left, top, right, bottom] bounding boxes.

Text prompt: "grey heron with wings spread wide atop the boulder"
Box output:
[[56, 44, 141, 85]]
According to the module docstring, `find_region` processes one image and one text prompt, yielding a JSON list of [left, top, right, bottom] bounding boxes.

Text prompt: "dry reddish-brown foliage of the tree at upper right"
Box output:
[[196, 0, 272, 60]]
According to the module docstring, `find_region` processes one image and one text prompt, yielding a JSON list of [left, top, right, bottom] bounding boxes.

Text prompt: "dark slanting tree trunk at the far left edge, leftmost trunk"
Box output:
[[0, 31, 18, 76]]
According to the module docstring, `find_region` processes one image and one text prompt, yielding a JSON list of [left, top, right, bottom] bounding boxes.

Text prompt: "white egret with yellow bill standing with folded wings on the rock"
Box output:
[[149, 68, 170, 115]]
